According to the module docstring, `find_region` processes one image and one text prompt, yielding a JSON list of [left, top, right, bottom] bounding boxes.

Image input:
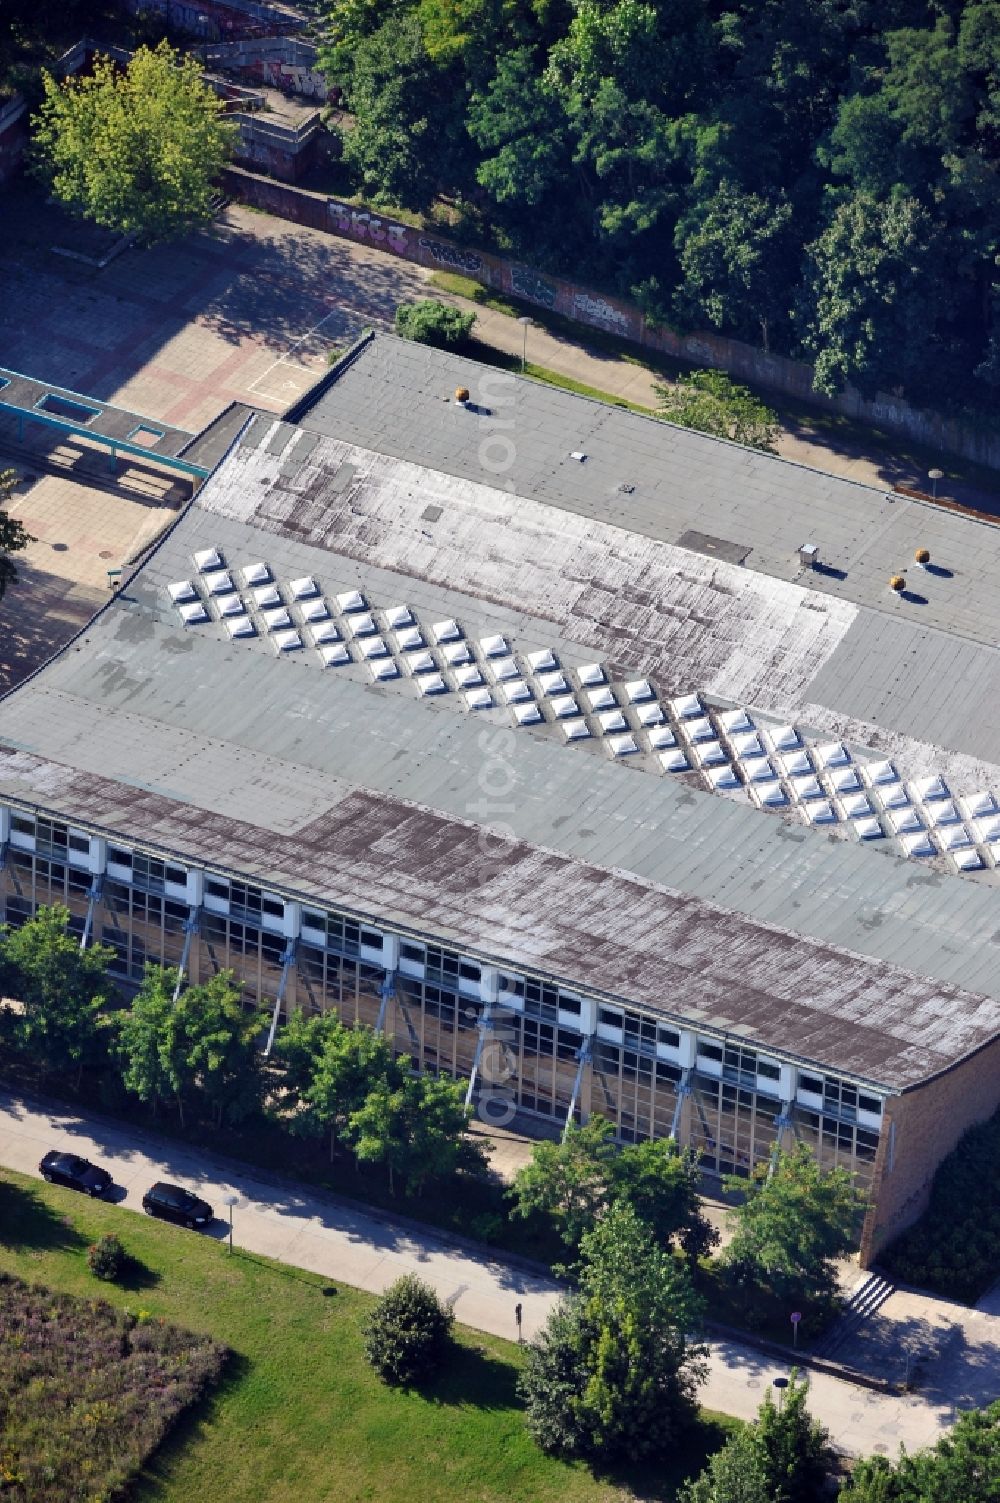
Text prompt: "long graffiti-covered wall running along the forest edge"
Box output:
[[227, 173, 1000, 469]]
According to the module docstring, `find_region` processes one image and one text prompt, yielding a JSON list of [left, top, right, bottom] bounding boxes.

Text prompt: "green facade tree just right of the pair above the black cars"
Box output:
[[278, 1013, 402, 1159]]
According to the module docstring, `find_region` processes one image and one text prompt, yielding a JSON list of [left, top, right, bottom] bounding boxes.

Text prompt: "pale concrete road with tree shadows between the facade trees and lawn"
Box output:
[[0, 1090, 968, 1455]]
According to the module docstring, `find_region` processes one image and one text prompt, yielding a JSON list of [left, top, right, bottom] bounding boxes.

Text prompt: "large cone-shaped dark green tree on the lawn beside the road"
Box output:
[[519, 1202, 704, 1459]]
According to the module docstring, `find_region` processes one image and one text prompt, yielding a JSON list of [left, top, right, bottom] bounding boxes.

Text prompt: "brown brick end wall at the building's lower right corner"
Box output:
[[862, 1042, 1000, 1266]]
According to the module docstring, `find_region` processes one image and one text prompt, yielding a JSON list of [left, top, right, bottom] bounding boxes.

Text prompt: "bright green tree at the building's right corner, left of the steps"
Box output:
[[722, 1142, 863, 1303]]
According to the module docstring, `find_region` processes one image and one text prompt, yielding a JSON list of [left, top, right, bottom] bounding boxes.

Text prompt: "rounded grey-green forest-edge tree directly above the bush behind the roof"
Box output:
[[675, 182, 797, 350]]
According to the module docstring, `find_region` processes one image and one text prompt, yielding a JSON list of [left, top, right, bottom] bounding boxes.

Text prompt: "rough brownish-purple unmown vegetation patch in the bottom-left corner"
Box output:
[[0, 1273, 226, 1503]]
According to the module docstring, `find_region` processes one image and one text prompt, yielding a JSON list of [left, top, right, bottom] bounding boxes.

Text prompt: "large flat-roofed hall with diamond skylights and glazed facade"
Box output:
[[0, 337, 1000, 1257]]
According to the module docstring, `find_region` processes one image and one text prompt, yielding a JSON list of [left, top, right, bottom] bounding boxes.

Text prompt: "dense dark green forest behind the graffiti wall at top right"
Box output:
[[323, 0, 1000, 413]]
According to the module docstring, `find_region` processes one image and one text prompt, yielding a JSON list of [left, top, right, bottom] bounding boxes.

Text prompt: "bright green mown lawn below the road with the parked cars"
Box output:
[[0, 1174, 734, 1503]]
